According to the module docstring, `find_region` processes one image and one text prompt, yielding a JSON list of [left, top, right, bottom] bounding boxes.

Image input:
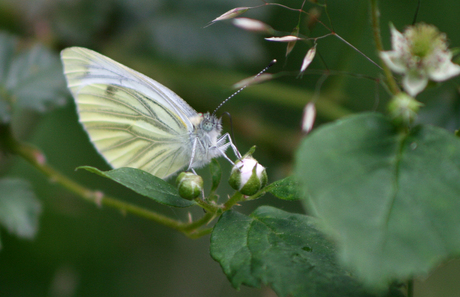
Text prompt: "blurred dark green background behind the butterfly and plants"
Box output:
[[0, 0, 460, 297]]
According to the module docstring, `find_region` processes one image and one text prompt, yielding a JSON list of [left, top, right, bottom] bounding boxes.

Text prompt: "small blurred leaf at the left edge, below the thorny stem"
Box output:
[[0, 178, 41, 239]]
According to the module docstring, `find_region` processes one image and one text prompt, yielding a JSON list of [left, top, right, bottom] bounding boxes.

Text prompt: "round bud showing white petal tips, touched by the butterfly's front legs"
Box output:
[[228, 156, 268, 196]]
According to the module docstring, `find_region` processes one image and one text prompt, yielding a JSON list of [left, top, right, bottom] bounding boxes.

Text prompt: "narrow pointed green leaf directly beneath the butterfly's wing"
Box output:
[[77, 166, 196, 207]]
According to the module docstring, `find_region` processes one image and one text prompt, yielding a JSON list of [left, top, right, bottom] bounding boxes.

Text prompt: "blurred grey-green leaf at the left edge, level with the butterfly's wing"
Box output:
[[0, 33, 68, 123]]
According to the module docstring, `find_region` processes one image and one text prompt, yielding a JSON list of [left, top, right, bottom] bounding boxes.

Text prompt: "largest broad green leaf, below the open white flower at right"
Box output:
[[296, 114, 460, 287]]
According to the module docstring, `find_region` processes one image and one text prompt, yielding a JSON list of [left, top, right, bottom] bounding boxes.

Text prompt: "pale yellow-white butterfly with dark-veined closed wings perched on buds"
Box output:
[[61, 47, 241, 178]]
